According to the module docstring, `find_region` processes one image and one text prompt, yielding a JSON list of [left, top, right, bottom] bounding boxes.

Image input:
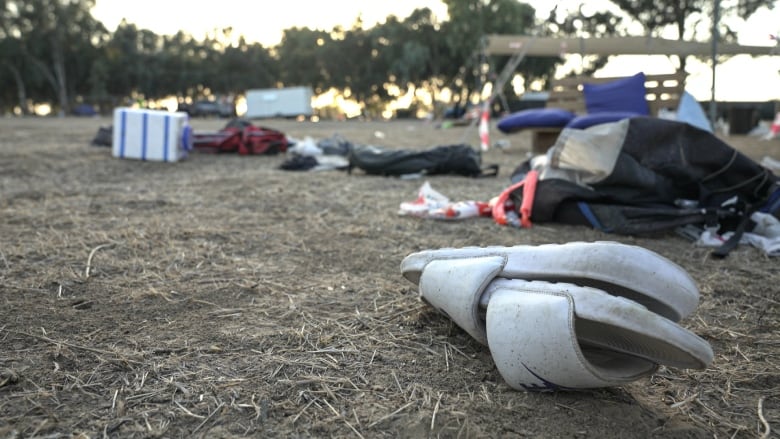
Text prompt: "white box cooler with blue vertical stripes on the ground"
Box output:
[[112, 108, 192, 162]]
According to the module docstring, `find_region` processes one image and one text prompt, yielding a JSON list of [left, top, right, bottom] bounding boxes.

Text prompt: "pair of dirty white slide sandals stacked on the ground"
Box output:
[[401, 242, 713, 390]]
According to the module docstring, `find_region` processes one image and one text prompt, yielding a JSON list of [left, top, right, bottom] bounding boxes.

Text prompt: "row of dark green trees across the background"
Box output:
[[0, 0, 772, 117]]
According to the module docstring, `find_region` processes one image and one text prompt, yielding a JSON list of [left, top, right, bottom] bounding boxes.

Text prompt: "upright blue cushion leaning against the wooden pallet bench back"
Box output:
[[582, 72, 650, 116]]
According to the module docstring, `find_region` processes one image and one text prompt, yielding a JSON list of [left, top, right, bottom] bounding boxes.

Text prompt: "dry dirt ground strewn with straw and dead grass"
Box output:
[[0, 118, 780, 438]]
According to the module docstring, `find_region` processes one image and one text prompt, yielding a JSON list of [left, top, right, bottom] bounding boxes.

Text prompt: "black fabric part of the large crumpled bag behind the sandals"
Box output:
[[502, 118, 780, 256]]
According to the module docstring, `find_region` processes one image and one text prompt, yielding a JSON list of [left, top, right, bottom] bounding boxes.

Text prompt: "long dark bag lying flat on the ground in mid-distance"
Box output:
[[348, 145, 498, 177]]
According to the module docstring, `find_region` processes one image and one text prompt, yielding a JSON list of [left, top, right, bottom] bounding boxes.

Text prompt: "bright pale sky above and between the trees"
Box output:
[[93, 0, 780, 101]]
